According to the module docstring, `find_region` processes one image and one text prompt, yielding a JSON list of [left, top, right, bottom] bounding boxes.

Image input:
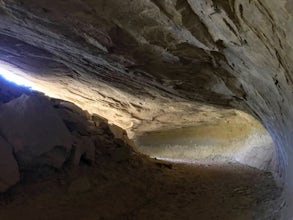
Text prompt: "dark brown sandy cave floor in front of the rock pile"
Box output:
[[0, 160, 280, 220]]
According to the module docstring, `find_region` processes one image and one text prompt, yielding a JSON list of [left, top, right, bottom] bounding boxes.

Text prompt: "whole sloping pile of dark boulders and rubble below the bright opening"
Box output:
[[0, 77, 133, 192]]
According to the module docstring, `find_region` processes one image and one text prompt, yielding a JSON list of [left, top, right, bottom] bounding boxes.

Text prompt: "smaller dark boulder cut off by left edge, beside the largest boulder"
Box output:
[[0, 137, 19, 192]]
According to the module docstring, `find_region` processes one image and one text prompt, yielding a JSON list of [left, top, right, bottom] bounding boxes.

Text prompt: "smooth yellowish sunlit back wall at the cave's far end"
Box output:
[[135, 110, 275, 171]]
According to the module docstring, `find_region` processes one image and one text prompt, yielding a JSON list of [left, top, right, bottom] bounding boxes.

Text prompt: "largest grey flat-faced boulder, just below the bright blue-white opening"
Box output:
[[0, 94, 72, 168]]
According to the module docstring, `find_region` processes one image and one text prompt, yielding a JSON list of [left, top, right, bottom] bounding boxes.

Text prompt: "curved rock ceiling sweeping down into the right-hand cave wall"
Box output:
[[0, 0, 293, 219]]
